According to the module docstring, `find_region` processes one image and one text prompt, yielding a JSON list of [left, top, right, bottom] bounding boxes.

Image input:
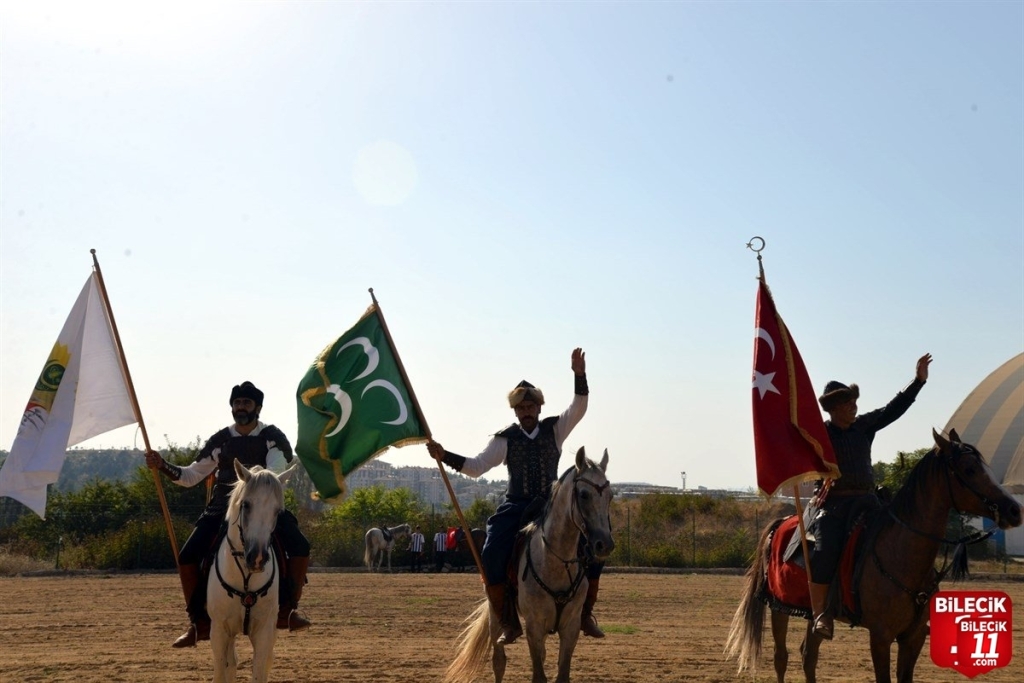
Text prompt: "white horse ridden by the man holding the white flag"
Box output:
[[207, 460, 297, 683]]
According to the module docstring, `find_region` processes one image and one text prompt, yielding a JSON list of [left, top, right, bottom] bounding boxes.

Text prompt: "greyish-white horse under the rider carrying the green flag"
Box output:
[[444, 449, 615, 683]]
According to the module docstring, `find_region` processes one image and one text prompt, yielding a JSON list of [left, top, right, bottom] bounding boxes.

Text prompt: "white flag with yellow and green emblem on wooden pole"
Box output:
[[0, 273, 137, 519]]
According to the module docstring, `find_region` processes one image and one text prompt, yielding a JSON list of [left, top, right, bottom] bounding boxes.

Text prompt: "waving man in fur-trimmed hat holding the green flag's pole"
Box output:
[[427, 348, 604, 645]]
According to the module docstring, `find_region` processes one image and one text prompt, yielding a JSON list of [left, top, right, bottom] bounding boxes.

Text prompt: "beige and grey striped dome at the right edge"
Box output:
[[946, 353, 1024, 555]]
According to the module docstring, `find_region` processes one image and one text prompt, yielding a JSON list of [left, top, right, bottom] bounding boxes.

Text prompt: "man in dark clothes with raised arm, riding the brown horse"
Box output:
[[809, 353, 932, 640]]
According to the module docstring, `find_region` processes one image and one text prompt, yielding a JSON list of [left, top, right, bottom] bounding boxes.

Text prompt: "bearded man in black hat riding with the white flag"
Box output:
[[145, 382, 309, 647]]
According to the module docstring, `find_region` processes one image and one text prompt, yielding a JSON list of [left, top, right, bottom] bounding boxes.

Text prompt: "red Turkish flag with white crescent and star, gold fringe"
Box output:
[[753, 281, 839, 496]]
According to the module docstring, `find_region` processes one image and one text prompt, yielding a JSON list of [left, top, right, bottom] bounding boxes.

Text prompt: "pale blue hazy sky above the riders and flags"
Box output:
[[0, 0, 1024, 489]]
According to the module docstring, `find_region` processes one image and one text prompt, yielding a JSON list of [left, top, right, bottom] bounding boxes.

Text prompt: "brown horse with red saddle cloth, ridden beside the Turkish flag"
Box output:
[[725, 430, 1021, 683]]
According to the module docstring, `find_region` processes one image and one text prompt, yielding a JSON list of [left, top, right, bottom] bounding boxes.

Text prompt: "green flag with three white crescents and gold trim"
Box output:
[[295, 303, 428, 503]]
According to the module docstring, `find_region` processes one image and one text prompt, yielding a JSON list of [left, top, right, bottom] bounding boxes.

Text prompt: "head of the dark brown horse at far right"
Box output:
[[932, 429, 1021, 529]]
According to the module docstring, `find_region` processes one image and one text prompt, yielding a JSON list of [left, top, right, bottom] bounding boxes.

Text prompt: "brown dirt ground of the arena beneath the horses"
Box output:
[[0, 572, 1024, 683]]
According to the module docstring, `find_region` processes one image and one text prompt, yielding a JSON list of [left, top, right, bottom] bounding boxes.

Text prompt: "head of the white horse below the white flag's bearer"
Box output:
[[227, 460, 296, 572]]
